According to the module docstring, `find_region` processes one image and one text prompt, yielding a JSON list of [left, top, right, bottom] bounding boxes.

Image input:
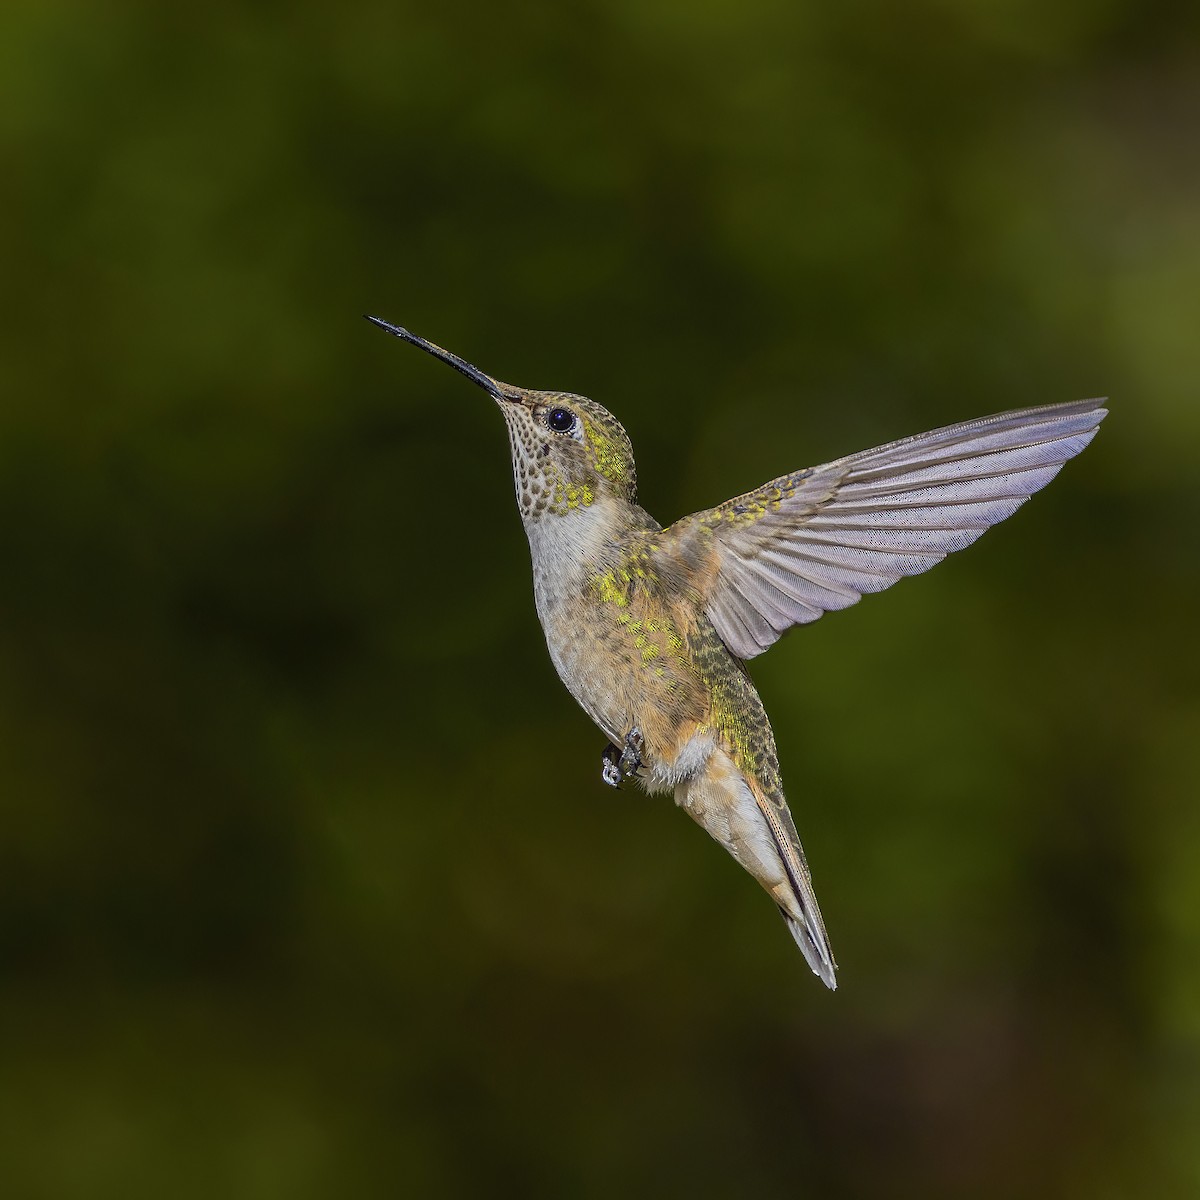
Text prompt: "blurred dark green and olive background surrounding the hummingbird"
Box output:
[[0, 0, 1200, 1200]]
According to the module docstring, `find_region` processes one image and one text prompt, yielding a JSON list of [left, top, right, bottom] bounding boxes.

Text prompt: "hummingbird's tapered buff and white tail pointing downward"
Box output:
[[676, 750, 838, 990]]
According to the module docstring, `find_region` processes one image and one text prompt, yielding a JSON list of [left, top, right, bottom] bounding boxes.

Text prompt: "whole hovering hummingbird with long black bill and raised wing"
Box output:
[[367, 317, 1106, 989]]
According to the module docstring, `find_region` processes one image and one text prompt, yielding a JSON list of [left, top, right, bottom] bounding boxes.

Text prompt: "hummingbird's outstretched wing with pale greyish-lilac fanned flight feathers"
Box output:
[[662, 400, 1106, 659]]
